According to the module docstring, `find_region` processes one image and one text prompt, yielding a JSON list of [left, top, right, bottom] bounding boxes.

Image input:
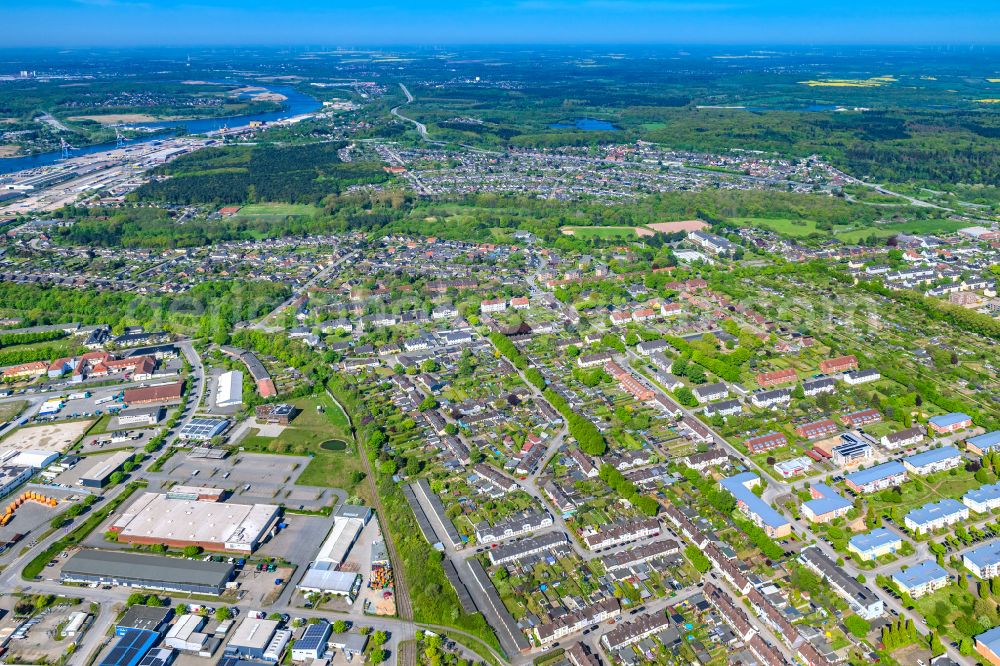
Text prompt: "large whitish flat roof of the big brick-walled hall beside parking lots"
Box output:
[[111, 493, 279, 550]]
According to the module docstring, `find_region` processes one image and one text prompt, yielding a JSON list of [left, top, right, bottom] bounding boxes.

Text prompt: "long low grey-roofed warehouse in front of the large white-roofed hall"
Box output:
[[60, 550, 234, 595]]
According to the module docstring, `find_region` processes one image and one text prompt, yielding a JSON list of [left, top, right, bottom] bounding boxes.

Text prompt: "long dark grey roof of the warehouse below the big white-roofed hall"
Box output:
[[62, 550, 233, 587]]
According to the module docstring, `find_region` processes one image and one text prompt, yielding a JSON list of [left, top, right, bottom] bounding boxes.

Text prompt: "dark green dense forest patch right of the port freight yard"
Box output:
[[132, 142, 389, 204]]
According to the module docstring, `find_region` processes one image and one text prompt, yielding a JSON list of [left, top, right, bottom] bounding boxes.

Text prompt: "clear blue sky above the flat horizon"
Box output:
[[0, 0, 1000, 47]]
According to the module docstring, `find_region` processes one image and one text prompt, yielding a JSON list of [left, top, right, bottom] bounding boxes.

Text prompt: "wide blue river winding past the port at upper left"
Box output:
[[0, 84, 323, 173]]
